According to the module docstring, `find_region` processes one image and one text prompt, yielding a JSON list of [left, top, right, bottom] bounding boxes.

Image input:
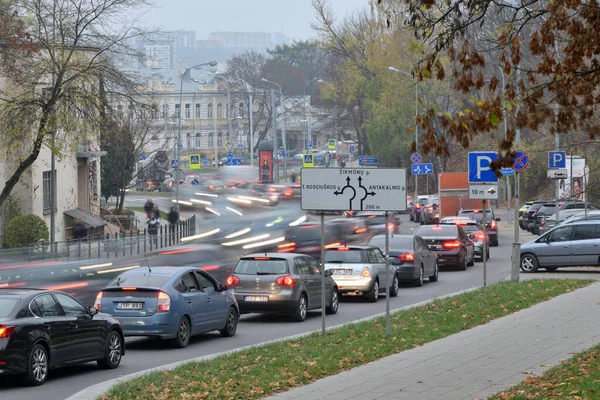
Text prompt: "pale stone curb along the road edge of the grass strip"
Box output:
[[66, 286, 480, 400]]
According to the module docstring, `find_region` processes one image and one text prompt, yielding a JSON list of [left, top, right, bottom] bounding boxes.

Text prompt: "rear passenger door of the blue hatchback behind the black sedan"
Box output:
[[174, 271, 210, 334]]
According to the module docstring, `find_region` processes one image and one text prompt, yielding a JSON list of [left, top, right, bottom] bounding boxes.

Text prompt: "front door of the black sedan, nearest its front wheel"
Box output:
[[54, 293, 107, 359]]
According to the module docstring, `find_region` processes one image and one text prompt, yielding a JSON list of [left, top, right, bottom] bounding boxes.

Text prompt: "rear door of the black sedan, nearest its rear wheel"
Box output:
[[30, 293, 72, 365]]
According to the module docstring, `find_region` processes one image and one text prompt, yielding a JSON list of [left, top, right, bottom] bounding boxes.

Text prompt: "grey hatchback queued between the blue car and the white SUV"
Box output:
[[226, 253, 339, 322]]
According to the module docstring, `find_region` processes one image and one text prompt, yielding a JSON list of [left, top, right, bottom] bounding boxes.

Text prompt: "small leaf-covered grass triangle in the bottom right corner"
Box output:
[[492, 346, 600, 400]]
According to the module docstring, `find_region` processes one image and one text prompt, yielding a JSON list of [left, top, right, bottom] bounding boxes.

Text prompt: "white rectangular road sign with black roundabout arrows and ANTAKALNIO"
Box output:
[[300, 168, 406, 211]]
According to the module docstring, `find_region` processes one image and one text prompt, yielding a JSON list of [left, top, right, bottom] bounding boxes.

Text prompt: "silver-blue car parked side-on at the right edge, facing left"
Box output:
[[520, 220, 600, 272]]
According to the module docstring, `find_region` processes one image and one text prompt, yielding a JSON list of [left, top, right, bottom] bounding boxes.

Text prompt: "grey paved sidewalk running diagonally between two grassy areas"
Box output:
[[268, 283, 600, 400]]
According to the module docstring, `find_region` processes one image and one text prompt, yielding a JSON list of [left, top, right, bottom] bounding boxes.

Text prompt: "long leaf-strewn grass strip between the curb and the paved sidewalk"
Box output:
[[100, 279, 594, 400]]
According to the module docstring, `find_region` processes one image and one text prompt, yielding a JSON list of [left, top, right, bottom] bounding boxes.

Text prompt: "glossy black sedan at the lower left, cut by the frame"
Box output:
[[0, 287, 125, 386]]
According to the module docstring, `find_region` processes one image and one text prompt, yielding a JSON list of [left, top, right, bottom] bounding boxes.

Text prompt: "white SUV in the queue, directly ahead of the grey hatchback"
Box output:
[[323, 245, 399, 302]]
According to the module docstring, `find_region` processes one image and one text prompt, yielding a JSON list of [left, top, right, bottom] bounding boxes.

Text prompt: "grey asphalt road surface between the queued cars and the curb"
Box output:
[[0, 210, 600, 399]]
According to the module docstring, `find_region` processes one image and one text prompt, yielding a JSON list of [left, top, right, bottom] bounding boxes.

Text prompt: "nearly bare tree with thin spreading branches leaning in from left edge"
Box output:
[[0, 0, 147, 211]]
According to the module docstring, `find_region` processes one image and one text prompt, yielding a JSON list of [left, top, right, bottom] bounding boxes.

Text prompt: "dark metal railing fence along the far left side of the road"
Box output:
[[0, 215, 196, 263]]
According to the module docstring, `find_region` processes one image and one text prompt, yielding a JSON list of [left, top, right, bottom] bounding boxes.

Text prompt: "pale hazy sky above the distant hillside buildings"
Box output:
[[143, 0, 368, 39]]
